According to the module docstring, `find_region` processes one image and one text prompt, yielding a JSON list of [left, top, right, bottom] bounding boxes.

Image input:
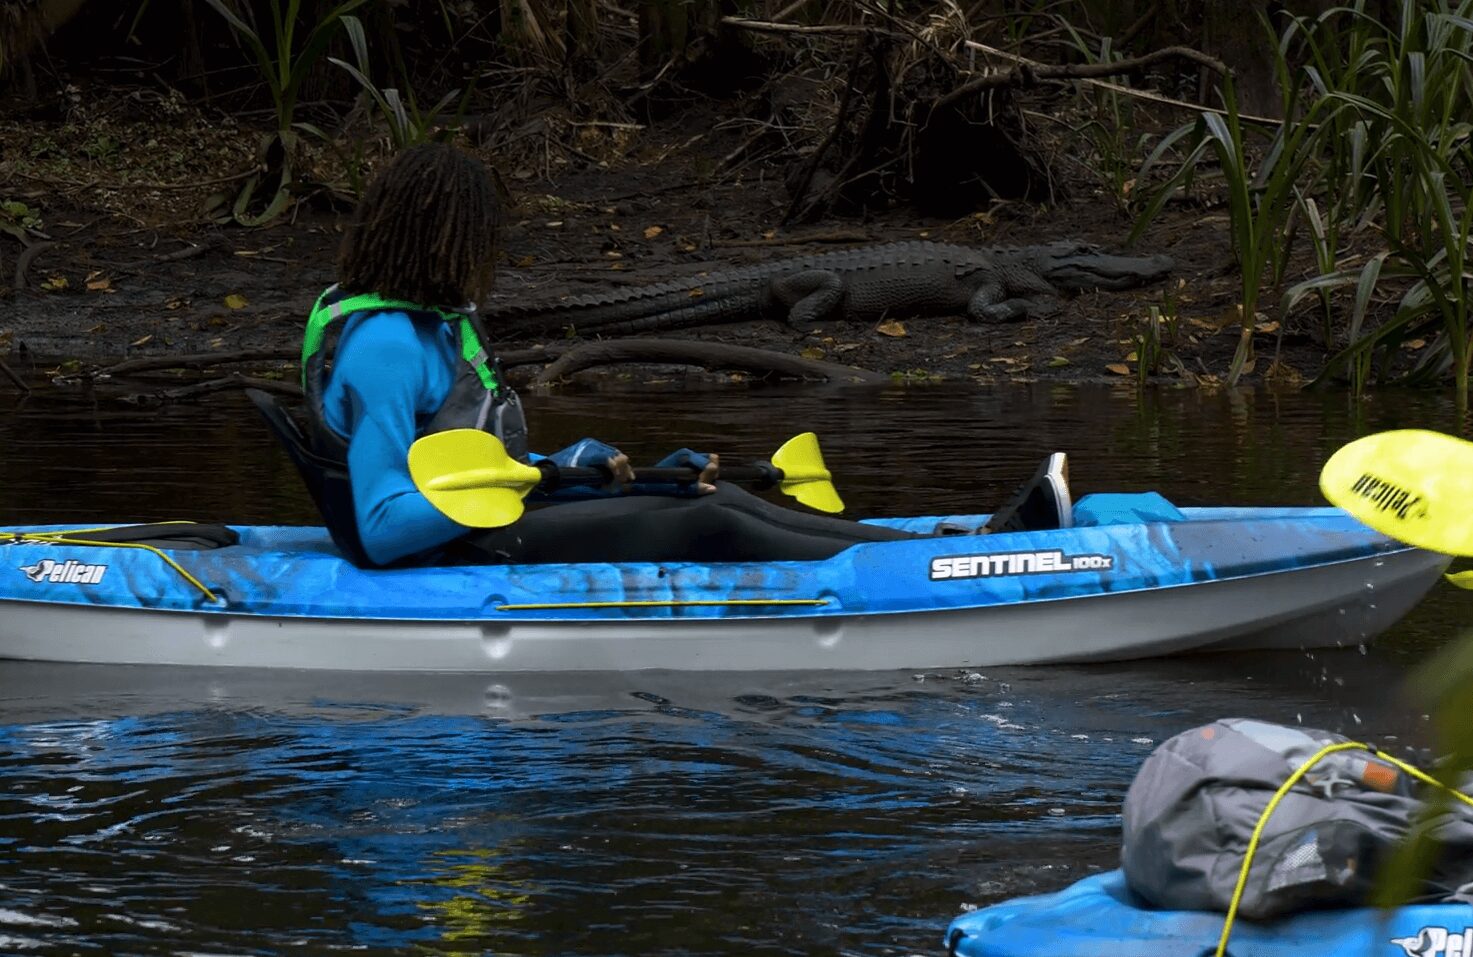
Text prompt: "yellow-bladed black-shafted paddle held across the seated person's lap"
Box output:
[[409, 428, 844, 529]]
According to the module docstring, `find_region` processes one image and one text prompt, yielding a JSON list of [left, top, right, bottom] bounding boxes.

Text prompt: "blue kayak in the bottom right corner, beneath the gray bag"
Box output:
[[946, 870, 1473, 957]]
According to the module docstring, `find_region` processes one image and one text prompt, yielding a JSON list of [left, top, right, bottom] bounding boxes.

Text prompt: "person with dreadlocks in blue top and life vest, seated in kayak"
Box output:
[[302, 144, 1071, 565]]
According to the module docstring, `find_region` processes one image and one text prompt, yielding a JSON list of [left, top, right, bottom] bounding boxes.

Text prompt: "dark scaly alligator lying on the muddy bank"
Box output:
[[485, 241, 1173, 336]]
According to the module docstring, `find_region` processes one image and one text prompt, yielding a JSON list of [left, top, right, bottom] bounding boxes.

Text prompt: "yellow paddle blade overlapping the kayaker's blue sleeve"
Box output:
[[409, 428, 542, 529]]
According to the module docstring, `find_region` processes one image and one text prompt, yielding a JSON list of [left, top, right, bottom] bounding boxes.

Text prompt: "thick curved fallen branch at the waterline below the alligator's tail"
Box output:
[[536, 339, 890, 386]]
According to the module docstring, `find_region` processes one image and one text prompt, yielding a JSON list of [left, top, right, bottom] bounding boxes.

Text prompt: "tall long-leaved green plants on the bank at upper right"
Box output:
[[1136, 0, 1473, 409]]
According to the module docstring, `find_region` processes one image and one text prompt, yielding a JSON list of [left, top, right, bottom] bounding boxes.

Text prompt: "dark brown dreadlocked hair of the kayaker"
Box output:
[[337, 143, 501, 308]]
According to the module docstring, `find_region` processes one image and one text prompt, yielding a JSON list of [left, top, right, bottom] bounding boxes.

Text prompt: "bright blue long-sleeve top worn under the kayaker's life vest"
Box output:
[[324, 312, 627, 564]]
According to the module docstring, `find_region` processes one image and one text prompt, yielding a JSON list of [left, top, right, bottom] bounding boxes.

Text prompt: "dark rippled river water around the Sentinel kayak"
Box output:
[[0, 386, 1473, 954]]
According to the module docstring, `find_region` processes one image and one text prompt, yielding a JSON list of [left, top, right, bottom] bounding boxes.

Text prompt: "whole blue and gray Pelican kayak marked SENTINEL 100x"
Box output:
[[0, 499, 1448, 673]]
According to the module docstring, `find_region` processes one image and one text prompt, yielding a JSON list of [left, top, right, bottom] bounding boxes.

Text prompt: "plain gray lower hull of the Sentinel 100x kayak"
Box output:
[[0, 549, 1449, 674]]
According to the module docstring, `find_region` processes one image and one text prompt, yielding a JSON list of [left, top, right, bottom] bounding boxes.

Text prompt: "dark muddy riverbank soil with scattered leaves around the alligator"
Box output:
[[0, 83, 1324, 387]]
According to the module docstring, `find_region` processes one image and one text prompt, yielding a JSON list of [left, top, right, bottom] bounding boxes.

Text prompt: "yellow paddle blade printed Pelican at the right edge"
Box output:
[[1320, 428, 1473, 555]]
